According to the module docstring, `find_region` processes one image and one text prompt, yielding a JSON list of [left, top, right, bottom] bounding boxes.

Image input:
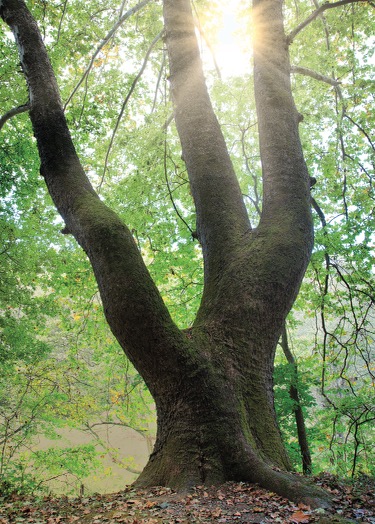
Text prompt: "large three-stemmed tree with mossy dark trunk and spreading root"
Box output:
[[0, 0, 372, 504]]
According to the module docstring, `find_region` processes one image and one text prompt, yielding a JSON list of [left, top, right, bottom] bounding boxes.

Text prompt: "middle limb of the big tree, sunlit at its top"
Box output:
[[164, 0, 250, 285]]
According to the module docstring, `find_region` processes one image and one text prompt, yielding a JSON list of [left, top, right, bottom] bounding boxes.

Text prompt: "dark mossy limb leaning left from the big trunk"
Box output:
[[0, 0, 185, 398]]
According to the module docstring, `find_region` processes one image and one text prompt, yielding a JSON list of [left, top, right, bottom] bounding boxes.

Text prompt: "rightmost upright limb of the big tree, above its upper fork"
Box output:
[[254, 0, 312, 254]]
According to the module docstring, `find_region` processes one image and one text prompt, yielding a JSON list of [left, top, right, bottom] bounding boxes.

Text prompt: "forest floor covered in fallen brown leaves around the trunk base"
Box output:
[[0, 474, 375, 524]]
